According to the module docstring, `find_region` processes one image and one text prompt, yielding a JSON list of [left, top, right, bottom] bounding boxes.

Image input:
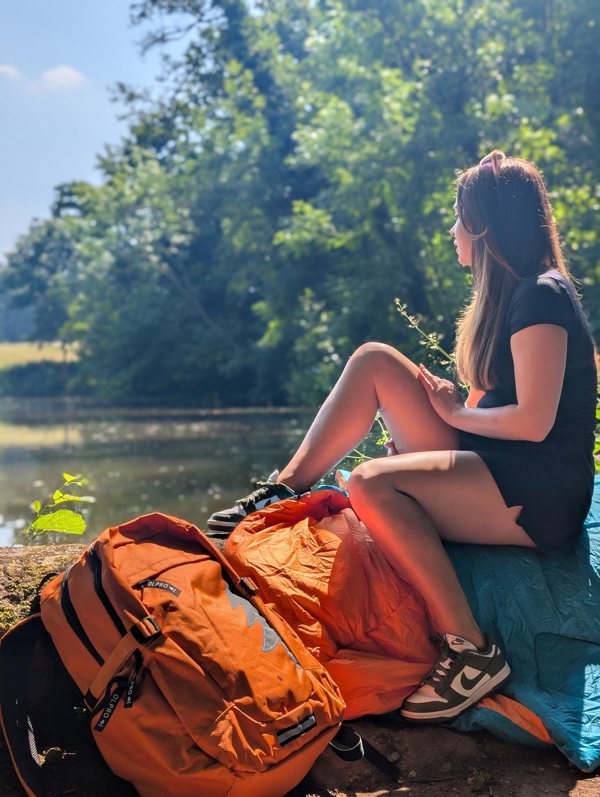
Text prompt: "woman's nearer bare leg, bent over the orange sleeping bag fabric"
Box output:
[[349, 451, 534, 647]]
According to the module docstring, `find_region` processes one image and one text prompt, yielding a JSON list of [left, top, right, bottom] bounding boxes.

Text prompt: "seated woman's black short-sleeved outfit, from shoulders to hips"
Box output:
[[460, 269, 597, 550]]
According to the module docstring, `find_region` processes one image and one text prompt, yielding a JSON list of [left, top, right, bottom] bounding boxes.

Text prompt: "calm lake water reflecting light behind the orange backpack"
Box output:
[[0, 399, 311, 546]]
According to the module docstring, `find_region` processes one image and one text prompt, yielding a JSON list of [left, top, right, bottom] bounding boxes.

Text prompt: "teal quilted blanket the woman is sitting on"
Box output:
[[448, 476, 600, 772]]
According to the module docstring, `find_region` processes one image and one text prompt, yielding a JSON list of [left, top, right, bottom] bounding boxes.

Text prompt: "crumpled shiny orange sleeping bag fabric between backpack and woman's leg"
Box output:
[[225, 489, 551, 742]]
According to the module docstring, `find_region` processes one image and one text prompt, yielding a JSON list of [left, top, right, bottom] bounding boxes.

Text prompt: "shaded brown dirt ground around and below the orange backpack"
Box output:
[[0, 545, 600, 797]]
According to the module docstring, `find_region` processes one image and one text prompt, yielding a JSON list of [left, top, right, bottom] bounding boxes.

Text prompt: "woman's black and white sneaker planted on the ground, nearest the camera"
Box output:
[[400, 634, 510, 722]]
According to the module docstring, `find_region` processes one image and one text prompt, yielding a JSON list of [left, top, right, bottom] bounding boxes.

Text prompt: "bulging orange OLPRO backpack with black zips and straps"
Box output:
[[0, 513, 344, 797]]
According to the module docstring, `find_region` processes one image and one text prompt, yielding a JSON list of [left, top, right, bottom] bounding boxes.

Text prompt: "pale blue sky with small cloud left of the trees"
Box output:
[[0, 0, 178, 260]]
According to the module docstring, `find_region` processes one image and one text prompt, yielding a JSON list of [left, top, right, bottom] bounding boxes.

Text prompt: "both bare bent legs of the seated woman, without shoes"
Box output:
[[279, 343, 533, 646]]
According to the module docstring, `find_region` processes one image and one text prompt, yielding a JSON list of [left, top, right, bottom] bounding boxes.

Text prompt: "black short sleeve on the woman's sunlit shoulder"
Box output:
[[509, 274, 575, 335]]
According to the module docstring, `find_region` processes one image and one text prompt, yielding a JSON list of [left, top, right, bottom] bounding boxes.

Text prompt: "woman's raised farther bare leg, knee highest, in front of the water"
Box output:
[[279, 343, 458, 492]]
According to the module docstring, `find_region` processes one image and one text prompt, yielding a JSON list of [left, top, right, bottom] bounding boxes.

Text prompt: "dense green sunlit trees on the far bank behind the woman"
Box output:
[[3, 0, 600, 405]]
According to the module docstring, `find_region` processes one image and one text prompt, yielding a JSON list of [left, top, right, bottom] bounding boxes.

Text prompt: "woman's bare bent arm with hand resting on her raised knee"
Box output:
[[420, 324, 567, 442]]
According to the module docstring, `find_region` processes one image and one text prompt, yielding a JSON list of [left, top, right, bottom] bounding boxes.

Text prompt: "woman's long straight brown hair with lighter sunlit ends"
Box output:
[[455, 150, 570, 390]]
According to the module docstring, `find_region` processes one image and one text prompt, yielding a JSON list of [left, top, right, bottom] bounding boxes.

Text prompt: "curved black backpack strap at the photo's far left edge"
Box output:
[[0, 614, 48, 797]]
